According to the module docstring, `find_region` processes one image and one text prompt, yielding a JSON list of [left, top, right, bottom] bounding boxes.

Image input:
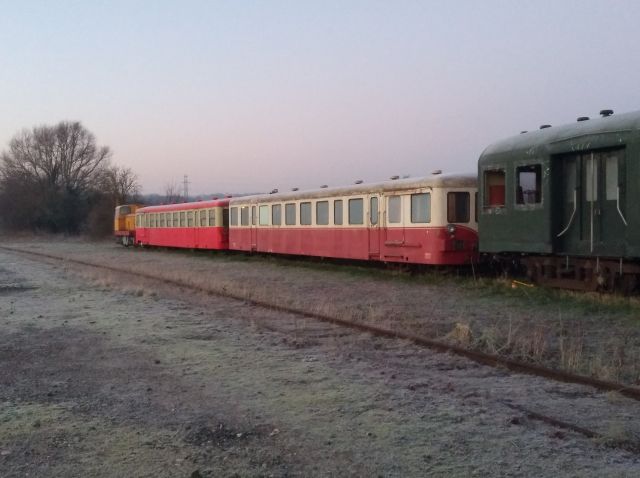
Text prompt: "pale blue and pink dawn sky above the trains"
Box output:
[[0, 0, 640, 194]]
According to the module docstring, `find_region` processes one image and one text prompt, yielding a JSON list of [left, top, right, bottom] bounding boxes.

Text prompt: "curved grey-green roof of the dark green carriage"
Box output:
[[480, 111, 640, 160]]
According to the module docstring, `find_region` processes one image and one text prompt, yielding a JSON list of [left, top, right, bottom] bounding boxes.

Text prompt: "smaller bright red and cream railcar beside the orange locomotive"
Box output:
[[136, 199, 229, 249]]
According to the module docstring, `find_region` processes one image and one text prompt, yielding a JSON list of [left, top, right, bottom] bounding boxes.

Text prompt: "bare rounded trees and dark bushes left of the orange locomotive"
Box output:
[[0, 121, 140, 236]]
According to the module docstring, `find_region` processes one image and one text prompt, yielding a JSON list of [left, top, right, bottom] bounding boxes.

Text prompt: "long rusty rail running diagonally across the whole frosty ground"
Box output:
[[0, 246, 640, 401]]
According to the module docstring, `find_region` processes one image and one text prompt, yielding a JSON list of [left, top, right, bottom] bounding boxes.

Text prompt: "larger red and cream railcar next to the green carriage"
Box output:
[[229, 174, 478, 265]]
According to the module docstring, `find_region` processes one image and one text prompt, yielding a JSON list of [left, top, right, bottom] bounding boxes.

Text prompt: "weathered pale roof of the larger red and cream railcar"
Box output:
[[226, 173, 478, 206]]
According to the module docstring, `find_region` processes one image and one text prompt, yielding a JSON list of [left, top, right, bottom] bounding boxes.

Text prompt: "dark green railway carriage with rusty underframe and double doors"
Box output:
[[478, 110, 640, 289]]
